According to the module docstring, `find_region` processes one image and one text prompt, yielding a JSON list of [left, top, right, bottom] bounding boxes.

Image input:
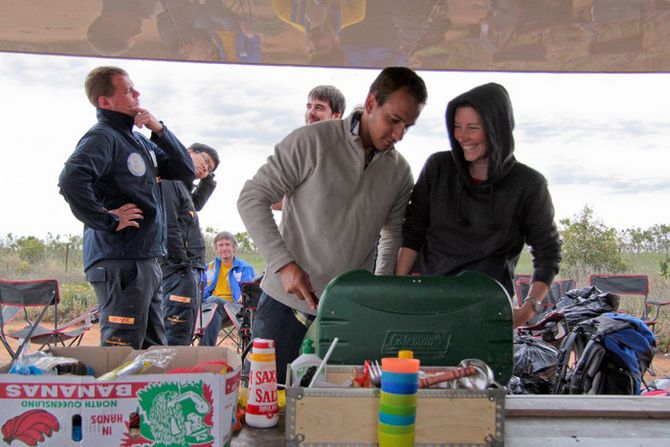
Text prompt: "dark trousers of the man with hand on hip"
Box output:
[[86, 258, 166, 349]]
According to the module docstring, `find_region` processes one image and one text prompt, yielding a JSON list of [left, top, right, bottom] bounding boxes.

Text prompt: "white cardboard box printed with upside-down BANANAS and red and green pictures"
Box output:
[[0, 346, 241, 447]]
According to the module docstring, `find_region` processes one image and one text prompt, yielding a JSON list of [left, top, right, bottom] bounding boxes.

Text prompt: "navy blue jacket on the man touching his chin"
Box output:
[[58, 109, 195, 270]]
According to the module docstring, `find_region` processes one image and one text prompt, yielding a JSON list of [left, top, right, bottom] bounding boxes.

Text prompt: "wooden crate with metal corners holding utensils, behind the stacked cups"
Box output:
[[285, 366, 505, 447]]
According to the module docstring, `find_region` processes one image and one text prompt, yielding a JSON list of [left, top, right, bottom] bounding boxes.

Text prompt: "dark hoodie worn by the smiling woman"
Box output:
[[402, 83, 561, 296]]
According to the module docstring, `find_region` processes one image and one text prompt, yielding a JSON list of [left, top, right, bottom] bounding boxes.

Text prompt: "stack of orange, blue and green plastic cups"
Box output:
[[377, 357, 419, 447]]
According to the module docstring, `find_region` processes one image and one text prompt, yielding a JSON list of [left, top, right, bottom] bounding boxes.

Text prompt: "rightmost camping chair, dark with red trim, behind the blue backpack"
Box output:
[[589, 274, 670, 328]]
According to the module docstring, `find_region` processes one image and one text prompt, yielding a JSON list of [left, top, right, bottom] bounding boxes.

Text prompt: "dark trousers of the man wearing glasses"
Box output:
[[162, 269, 200, 346]]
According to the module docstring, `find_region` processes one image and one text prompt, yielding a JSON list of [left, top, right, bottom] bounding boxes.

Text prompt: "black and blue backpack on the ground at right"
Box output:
[[554, 312, 656, 395]]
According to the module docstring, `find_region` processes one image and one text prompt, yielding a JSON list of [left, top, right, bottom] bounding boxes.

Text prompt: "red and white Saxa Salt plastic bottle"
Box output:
[[245, 338, 279, 428]]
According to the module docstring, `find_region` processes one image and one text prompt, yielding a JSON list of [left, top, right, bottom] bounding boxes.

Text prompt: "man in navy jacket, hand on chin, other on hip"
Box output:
[[59, 67, 195, 349]]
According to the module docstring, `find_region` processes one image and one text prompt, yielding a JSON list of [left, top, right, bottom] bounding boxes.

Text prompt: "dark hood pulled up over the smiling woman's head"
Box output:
[[445, 82, 515, 183]]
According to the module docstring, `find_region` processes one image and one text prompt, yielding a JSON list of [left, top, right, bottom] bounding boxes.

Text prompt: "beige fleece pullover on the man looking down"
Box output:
[[237, 114, 413, 315]]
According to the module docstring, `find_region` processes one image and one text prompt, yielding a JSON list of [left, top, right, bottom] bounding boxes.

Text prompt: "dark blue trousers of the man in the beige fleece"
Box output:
[[251, 292, 311, 383]]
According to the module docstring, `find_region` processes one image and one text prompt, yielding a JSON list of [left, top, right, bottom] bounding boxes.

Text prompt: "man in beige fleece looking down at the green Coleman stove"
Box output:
[[237, 67, 427, 382]]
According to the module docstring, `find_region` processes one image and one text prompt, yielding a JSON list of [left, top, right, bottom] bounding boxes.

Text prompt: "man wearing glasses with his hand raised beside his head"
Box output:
[[161, 143, 219, 346]]
